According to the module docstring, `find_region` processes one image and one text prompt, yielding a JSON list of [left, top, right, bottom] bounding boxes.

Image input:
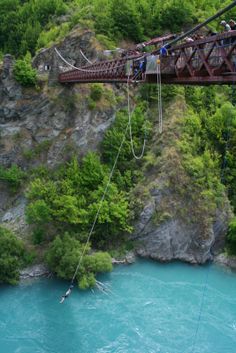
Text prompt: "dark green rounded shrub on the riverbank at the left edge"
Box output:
[[0, 227, 26, 284]]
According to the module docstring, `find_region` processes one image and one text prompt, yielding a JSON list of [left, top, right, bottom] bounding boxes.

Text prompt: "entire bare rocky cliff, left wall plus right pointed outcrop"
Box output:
[[0, 28, 231, 263]]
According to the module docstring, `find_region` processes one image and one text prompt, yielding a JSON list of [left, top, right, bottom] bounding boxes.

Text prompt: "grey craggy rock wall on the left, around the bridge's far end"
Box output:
[[0, 28, 123, 233]]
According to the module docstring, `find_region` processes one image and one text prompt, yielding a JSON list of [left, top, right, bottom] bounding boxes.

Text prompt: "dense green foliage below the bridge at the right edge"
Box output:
[[182, 87, 236, 211]]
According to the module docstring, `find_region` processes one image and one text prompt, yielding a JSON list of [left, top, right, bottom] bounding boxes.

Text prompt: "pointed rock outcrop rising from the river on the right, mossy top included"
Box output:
[[131, 97, 232, 263]]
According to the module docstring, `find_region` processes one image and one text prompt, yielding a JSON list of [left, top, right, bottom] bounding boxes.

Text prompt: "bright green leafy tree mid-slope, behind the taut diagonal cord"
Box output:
[[26, 153, 131, 243]]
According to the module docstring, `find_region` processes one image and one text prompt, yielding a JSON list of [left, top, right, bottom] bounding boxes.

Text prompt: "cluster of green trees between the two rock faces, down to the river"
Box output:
[[26, 105, 150, 288]]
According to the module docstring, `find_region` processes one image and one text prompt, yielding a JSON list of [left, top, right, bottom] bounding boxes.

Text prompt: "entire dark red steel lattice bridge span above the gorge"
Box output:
[[59, 31, 236, 85]]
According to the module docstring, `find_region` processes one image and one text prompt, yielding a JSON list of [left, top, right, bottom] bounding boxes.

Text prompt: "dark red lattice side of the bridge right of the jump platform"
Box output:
[[162, 31, 236, 77]]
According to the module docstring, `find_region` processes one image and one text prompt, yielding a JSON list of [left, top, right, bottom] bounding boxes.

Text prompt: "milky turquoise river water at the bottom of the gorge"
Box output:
[[0, 260, 236, 353]]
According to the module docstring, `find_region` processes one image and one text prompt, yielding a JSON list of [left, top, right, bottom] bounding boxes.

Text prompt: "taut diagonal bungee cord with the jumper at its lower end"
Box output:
[[60, 121, 129, 303]]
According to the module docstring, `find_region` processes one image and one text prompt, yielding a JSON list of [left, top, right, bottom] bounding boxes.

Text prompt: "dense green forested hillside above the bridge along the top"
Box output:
[[0, 0, 235, 56]]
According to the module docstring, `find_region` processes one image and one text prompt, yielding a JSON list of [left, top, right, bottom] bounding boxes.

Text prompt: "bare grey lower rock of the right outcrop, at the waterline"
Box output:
[[132, 198, 229, 263]]
